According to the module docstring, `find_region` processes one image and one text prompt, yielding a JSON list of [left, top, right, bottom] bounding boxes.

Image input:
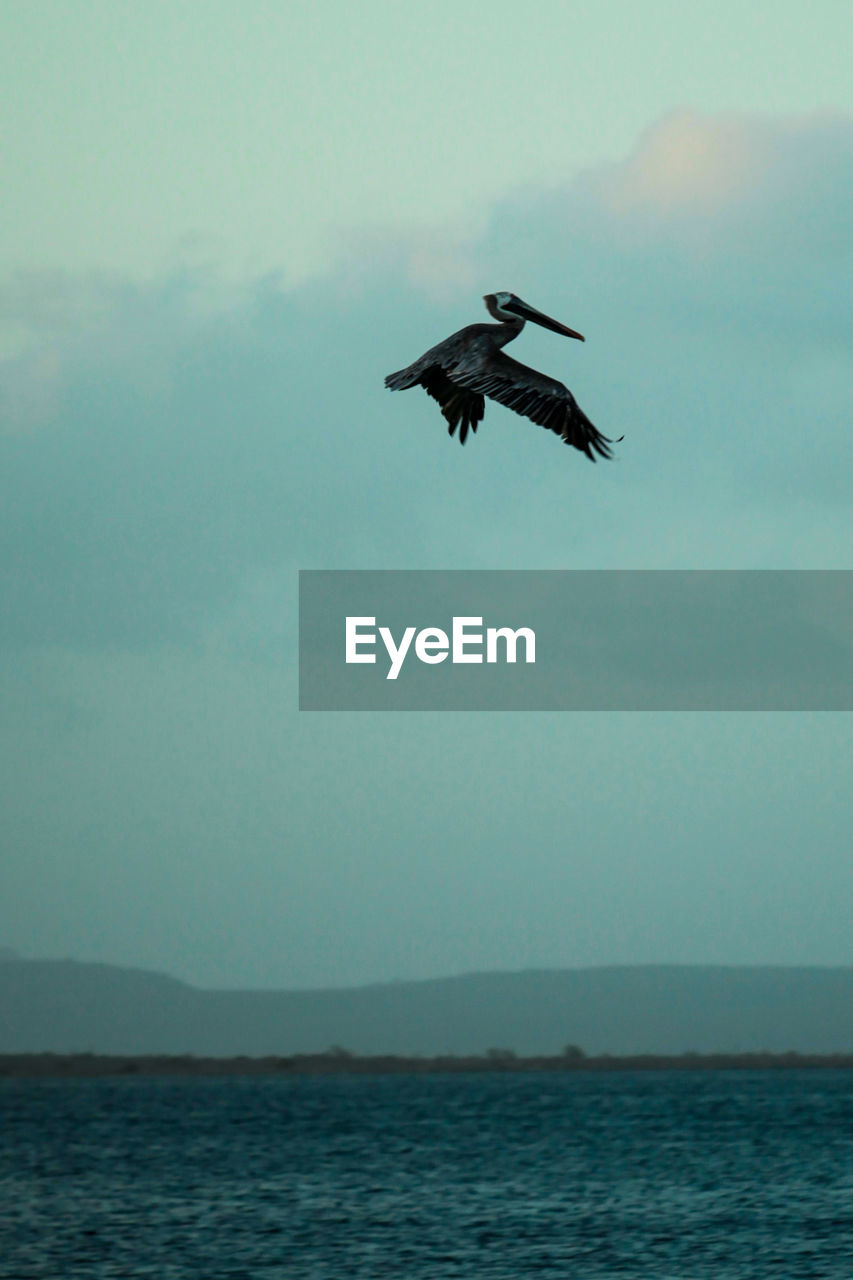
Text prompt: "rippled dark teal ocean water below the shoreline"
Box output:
[[0, 1071, 853, 1280]]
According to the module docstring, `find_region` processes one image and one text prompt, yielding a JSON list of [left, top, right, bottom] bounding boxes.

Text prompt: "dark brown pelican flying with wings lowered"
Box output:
[[386, 293, 621, 462]]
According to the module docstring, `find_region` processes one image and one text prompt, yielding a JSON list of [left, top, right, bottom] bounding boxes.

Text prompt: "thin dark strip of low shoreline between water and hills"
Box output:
[[0, 1051, 853, 1079]]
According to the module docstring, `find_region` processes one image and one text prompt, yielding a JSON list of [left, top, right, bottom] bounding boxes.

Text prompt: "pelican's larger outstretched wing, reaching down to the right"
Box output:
[[448, 351, 621, 462]]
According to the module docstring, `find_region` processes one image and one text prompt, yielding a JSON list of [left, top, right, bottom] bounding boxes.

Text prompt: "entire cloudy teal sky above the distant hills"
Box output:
[[0, 0, 853, 987]]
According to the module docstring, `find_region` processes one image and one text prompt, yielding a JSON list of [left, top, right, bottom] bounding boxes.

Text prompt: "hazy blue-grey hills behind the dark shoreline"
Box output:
[[0, 947, 853, 1056]]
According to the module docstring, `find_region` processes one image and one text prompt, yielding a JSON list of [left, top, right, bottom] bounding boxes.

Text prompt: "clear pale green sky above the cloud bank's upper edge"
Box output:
[[0, 0, 853, 278]]
